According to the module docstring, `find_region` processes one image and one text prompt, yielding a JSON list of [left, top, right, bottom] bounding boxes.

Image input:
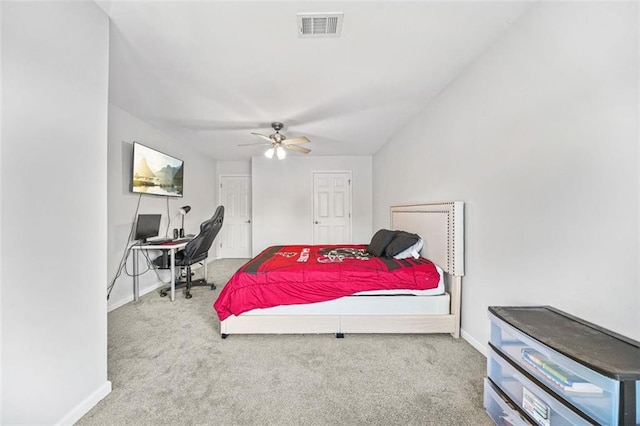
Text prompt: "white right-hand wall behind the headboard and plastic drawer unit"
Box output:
[[373, 2, 640, 345]]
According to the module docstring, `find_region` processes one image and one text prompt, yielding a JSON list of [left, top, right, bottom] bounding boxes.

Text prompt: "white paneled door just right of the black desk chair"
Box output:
[[218, 175, 251, 258]]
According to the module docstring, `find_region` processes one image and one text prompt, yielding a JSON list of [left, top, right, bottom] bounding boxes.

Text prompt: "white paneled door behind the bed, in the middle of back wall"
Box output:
[[313, 172, 351, 244]]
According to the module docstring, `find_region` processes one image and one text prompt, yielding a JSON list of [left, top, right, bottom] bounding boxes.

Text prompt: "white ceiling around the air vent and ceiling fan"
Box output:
[[106, 1, 531, 160]]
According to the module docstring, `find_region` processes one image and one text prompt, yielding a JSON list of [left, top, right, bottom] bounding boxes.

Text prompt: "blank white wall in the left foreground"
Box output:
[[0, 2, 111, 425]]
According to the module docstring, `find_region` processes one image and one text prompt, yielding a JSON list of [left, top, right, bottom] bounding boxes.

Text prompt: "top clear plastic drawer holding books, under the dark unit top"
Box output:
[[489, 313, 620, 425]]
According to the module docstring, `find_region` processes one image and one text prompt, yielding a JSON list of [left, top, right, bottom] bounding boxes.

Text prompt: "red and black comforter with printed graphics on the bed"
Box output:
[[213, 245, 440, 321]]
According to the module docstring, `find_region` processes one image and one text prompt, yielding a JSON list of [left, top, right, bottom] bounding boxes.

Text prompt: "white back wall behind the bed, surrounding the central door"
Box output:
[[251, 156, 372, 255]]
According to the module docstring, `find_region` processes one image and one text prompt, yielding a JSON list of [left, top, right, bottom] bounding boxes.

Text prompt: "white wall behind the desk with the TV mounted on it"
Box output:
[[108, 104, 218, 310]]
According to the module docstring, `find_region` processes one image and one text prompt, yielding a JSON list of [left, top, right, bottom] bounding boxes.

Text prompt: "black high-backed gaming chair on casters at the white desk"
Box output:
[[153, 206, 224, 299]]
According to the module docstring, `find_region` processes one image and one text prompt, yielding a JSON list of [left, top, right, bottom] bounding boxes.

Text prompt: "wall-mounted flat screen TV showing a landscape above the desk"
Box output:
[[131, 142, 184, 197]]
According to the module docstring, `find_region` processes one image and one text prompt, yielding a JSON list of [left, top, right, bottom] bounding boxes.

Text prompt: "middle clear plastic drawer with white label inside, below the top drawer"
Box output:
[[487, 348, 595, 426]]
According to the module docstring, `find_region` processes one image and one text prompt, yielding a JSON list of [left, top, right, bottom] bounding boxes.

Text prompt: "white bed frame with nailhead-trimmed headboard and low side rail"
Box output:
[[220, 201, 464, 338]]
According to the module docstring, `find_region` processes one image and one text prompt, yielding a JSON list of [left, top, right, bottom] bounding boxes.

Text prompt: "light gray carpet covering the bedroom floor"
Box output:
[[77, 259, 492, 426]]
